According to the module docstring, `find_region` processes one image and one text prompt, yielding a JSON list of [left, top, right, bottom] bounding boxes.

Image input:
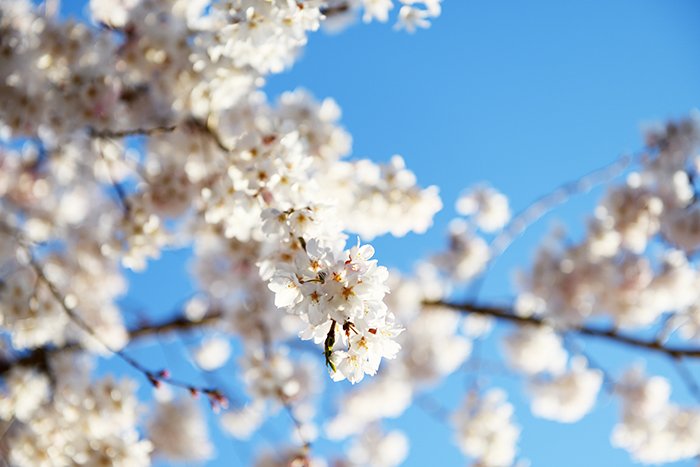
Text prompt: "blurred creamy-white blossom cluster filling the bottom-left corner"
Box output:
[[0, 359, 153, 467]]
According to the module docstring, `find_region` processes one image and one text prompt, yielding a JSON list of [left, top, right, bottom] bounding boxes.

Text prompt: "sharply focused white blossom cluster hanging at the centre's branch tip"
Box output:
[[269, 238, 401, 383]]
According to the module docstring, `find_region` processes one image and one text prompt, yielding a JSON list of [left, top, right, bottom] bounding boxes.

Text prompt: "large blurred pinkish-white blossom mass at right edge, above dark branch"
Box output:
[[519, 117, 700, 334]]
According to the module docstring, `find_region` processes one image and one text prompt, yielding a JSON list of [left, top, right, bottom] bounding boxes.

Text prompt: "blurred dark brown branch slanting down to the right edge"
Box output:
[[424, 302, 700, 358]]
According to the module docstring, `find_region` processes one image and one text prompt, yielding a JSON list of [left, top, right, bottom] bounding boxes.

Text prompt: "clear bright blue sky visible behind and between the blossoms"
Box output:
[[53, 0, 700, 467]]
